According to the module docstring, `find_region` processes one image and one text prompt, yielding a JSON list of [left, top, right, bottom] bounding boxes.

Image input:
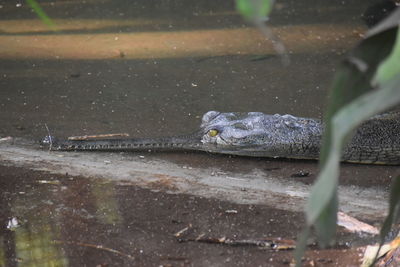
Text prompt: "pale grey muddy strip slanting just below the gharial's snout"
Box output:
[[0, 139, 394, 223]]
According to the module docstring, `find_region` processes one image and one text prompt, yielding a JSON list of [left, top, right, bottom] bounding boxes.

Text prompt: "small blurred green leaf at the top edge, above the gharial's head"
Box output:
[[236, 0, 273, 21]]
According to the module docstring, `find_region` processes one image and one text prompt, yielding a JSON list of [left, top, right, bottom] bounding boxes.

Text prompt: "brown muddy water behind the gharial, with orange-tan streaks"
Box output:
[[0, 1, 367, 142]]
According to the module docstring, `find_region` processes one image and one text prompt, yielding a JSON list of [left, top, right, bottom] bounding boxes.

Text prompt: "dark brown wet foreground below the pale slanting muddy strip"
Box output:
[[0, 166, 361, 266]]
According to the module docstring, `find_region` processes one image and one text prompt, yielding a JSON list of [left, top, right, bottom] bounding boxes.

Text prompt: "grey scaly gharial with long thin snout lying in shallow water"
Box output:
[[42, 111, 400, 165]]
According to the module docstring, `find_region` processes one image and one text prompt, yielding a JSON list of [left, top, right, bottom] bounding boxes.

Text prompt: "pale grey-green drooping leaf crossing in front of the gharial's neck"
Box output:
[[306, 70, 400, 241]]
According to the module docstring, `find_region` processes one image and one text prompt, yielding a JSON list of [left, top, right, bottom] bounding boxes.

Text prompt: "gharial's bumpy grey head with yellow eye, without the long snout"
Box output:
[[200, 111, 321, 157]]
